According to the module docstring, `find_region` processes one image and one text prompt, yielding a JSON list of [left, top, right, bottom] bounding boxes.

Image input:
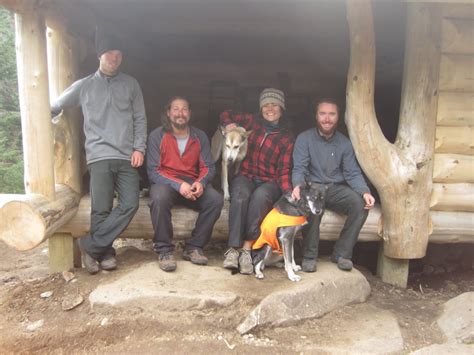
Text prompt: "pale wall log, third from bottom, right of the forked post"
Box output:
[[433, 154, 474, 184]]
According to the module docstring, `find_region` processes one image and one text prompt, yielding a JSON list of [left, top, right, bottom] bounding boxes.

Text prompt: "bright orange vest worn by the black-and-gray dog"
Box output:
[[252, 208, 306, 254]]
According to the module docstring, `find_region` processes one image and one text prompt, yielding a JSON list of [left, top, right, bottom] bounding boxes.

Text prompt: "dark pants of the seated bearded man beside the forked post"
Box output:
[[303, 185, 368, 259]]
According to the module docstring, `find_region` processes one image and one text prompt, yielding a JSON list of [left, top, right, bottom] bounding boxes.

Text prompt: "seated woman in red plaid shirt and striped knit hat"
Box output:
[[220, 88, 294, 274]]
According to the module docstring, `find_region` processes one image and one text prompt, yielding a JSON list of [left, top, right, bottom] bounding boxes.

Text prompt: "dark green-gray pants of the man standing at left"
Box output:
[[79, 159, 139, 260]]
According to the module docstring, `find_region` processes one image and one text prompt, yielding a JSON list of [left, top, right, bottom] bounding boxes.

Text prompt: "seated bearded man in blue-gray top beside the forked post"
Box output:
[[292, 99, 375, 272]]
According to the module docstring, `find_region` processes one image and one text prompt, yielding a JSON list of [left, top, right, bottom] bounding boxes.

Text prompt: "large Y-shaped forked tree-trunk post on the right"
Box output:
[[346, 0, 441, 259]]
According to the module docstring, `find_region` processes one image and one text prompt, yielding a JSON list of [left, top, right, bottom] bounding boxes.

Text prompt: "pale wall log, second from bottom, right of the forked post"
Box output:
[[431, 184, 474, 212]]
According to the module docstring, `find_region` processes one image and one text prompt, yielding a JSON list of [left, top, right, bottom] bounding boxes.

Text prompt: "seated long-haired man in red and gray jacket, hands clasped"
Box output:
[[146, 97, 224, 271]]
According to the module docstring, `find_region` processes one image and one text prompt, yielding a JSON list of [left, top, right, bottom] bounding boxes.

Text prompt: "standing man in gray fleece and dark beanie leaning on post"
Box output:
[[51, 37, 147, 274]]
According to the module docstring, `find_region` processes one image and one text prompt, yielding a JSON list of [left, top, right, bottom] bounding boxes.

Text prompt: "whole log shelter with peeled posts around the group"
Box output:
[[0, 0, 474, 287]]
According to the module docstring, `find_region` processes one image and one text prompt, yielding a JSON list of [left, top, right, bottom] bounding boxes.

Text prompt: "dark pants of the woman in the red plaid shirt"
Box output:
[[228, 176, 281, 248]]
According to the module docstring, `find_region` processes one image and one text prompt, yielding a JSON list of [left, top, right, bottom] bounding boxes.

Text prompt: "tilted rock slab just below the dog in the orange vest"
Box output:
[[237, 262, 370, 334]]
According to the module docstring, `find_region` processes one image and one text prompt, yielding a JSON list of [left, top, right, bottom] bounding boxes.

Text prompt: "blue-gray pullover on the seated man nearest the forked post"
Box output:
[[292, 128, 370, 196]]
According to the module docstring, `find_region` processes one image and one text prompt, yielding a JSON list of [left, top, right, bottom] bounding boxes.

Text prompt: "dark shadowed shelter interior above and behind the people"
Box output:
[[49, 0, 406, 142]]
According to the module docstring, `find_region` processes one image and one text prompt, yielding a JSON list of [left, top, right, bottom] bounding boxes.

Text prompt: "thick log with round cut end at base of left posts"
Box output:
[[0, 185, 80, 250]]
